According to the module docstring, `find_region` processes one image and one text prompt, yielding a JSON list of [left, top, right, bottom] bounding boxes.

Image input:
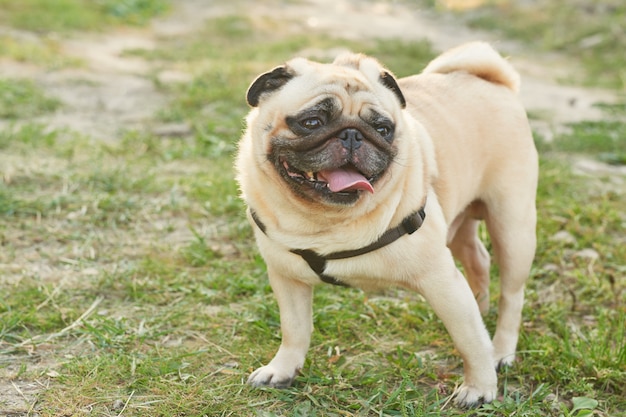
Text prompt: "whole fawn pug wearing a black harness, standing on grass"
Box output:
[[236, 42, 538, 406]]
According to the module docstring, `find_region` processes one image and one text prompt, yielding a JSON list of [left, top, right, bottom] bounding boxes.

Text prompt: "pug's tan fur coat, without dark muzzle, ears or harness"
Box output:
[[237, 43, 538, 405]]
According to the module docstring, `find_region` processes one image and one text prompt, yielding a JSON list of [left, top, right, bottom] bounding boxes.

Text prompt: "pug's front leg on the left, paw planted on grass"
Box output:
[[248, 267, 313, 388]]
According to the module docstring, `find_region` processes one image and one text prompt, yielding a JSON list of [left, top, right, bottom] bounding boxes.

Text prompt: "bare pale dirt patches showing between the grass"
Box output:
[[0, 0, 626, 416]]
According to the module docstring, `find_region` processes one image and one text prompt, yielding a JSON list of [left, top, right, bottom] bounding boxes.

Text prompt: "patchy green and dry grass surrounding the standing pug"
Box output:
[[0, 3, 626, 417]]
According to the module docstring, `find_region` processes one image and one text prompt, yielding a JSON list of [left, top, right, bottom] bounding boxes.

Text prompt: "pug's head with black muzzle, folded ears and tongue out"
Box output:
[[247, 55, 405, 206]]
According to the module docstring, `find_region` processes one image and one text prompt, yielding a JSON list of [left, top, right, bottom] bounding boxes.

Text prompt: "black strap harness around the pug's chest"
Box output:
[[250, 205, 426, 287]]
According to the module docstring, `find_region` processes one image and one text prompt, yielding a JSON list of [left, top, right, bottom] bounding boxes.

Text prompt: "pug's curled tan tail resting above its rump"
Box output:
[[423, 42, 520, 92]]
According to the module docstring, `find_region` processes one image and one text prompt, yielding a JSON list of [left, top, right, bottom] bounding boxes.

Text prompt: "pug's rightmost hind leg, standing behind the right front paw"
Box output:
[[485, 196, 537, 367]]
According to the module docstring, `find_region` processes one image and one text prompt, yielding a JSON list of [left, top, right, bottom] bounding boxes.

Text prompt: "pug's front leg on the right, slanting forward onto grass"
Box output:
[[420, 258, 497, 406]]
